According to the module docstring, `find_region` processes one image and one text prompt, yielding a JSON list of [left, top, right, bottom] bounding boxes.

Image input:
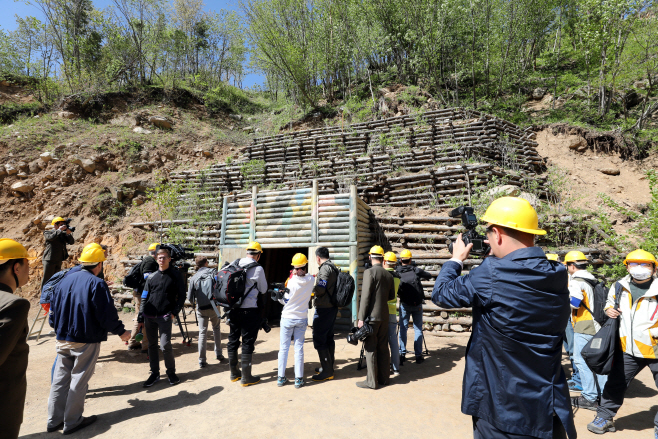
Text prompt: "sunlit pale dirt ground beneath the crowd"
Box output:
[[20, 314, 658, 439]]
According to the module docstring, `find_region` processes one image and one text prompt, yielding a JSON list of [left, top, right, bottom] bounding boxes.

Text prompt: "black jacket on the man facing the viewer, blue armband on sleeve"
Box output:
[[138, 267, 186, 322]]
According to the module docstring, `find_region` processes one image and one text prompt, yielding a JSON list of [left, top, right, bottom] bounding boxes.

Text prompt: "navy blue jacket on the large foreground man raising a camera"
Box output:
[[432, 247, 576, 439]]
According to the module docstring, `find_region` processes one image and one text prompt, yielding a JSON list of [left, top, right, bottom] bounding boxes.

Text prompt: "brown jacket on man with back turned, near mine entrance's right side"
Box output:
[[358, 265, 395, 322]]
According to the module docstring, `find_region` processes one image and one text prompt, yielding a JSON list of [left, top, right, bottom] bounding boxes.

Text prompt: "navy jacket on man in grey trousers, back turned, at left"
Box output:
[[48, 270, 125, 343]]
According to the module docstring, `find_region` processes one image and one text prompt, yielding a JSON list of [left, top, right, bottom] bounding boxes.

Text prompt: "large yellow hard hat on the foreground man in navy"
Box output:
[[482, 197, 546, 235]]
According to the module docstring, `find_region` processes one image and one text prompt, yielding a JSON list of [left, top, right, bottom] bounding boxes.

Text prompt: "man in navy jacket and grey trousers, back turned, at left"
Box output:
[[47, 243, 130, 434]]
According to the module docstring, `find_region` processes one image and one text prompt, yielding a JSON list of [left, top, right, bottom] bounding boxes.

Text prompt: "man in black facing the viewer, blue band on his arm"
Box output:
[[137, 246, 185, 387]]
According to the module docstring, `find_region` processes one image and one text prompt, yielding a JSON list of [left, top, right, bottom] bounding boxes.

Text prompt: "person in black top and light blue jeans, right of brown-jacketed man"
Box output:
[[395, 249, 432, 364]]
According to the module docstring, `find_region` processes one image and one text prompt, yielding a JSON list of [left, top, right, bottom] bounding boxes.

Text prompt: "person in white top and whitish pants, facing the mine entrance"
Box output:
[[277, 253, 315, 389]]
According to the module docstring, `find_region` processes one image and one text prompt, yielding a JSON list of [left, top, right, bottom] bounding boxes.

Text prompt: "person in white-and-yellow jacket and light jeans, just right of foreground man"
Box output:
[[564, 250, 608, 410]]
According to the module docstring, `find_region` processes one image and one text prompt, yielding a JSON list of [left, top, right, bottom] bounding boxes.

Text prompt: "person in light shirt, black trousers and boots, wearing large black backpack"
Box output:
[[226, 241, 268, 387]]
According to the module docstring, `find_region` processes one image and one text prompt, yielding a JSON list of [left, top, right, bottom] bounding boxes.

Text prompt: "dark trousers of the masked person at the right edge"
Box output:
[[596, 349, 658, 427]]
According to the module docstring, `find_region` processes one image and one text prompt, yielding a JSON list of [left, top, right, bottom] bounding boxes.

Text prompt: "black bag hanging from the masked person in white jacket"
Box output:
[[580, 282, 622, 375]]
